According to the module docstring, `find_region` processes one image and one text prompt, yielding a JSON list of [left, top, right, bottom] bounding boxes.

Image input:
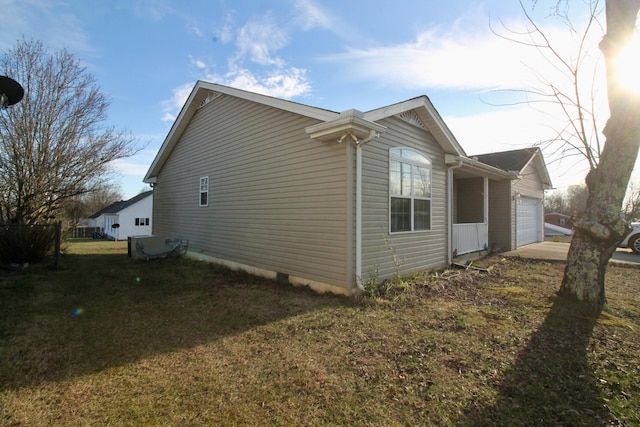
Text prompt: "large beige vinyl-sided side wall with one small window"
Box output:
[[154, 96, 351, 287]]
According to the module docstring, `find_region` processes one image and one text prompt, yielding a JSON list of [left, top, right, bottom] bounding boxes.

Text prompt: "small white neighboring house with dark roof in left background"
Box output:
[[88, 191, 153, 240]]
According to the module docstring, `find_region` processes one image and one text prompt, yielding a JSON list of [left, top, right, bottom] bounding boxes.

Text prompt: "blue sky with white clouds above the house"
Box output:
[[0, 0, 640, 199]]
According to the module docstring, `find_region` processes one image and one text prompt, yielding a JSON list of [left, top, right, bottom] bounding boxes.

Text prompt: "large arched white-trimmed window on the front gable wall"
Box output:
[[389, 148, 431, 233]]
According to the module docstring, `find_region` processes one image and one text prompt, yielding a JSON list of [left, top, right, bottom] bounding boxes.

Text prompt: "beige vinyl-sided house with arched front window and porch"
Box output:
[[144, 81, 548, 294]]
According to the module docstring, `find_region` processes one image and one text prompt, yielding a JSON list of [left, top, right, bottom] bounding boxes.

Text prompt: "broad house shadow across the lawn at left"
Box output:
[[0, 254, 354, 390]]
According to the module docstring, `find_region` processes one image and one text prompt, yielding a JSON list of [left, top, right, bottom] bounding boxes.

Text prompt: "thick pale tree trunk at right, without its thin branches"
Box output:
[[559, 0, 640, 313]]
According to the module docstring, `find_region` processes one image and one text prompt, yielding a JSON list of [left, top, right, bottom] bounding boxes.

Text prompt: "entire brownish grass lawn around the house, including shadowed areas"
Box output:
[[0, 241, 640, 426]]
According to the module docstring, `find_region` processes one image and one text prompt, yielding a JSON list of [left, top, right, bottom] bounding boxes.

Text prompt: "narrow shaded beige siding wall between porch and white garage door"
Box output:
[[489, 179, 513, 252]]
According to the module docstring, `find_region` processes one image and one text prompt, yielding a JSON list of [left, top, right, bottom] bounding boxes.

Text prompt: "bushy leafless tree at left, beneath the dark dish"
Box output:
[[0, 40, 140, 224]]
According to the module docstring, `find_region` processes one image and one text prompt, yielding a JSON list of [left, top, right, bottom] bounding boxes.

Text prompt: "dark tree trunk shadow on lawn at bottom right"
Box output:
[[462, 297, 610, 426]]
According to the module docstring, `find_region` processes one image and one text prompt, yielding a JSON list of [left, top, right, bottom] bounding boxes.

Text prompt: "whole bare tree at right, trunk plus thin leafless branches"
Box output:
[[508, 0, 640, 312]]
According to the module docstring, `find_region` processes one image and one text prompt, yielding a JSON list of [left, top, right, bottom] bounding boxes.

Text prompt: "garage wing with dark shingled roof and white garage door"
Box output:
[[474, 147, 551, 251]]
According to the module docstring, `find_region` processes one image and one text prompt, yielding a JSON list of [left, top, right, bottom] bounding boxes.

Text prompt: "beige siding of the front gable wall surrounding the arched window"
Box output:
[[362, 117, 447, 278]]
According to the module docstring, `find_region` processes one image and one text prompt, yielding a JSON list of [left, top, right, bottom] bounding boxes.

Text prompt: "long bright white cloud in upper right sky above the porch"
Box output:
[[322, 12, 601, 90]]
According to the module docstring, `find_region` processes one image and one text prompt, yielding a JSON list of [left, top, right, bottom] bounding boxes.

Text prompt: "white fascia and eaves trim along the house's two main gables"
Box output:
[[144, 80, 465, 183]]
